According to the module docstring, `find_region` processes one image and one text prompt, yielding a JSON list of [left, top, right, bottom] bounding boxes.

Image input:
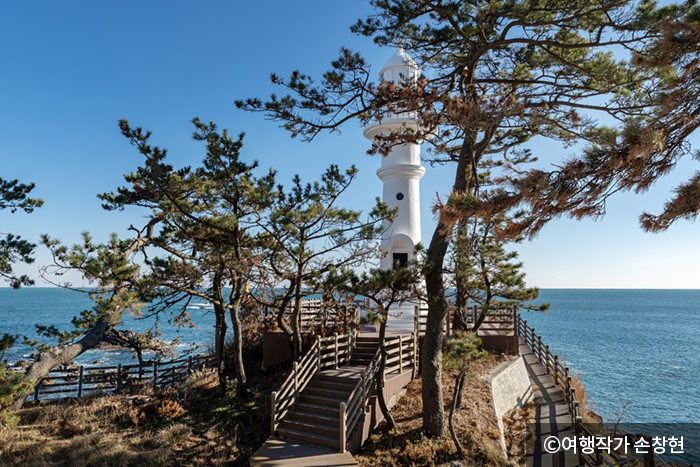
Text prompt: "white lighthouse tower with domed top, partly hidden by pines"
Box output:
[[364, 49, 425, 269]]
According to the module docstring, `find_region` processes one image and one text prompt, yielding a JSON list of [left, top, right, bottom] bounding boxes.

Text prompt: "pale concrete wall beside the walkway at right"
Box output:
[[485, 356, 534, 453]]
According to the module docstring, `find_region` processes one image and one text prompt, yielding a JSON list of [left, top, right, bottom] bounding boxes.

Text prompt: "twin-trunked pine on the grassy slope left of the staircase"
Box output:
[[100, 119, 277, 397]]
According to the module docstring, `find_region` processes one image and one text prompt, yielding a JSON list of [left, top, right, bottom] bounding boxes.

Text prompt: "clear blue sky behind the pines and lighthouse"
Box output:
[[0, 0, 700, 288]]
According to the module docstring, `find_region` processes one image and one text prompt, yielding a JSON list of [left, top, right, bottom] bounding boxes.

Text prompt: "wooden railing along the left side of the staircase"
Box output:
[[270, 333, 355, 437]]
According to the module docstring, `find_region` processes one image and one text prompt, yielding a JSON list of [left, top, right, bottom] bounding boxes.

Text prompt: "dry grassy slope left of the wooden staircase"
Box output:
[[0, 346, 283, 467]]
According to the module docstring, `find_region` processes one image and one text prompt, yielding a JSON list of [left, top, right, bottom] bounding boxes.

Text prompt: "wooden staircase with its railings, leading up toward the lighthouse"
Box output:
[[271, 334, 410, 452]]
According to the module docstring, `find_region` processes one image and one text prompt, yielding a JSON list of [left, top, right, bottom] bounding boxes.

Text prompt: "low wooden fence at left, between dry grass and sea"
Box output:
[[34, 355, 214, 401]]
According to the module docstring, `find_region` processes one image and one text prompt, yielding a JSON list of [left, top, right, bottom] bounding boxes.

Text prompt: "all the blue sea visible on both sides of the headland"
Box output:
[[0, 288, 700, 423]]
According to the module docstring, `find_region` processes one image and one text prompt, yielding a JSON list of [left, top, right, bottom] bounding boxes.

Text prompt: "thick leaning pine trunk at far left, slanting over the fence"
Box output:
[[12, 318, 111, 410]]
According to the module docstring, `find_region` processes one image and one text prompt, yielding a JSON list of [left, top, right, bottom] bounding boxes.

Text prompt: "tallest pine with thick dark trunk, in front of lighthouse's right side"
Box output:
[[237, 0, 697, 435]]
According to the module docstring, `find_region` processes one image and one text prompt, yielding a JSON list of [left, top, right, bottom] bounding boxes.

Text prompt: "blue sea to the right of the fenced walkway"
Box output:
[[523, 289, 700, 423]]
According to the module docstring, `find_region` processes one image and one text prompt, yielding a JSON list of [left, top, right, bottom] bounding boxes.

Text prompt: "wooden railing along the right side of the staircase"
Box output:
[[339, 333, 418, 452]]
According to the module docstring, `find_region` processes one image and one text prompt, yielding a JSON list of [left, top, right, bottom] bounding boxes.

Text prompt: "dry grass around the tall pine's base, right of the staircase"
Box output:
[[355, 355, 513, 467]]
